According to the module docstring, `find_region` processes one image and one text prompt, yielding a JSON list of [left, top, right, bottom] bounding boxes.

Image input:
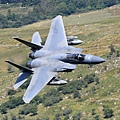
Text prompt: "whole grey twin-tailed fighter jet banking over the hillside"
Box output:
[[6, 15, 105, 103]]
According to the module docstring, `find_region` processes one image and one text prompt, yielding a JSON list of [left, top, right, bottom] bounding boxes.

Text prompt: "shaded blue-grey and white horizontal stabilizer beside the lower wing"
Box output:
[[14, 72, 31, 89]]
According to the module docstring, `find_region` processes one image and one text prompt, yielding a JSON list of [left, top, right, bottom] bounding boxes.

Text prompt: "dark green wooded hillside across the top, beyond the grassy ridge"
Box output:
[[0, 0, 120, 28]]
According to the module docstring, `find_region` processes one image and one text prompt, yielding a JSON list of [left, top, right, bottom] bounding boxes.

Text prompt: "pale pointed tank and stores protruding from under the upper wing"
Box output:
[[67, 36, 83, 45]]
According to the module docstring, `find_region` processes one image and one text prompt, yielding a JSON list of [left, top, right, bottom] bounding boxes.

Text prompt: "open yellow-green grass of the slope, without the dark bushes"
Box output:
[[0, 5, 120, 120]]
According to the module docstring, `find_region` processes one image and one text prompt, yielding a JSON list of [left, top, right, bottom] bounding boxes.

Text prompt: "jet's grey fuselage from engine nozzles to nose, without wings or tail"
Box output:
[[27, 47, 105, 69]]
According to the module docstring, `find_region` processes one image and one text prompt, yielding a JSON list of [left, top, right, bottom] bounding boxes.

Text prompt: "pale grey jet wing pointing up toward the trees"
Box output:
[[44, 15, 68, 51]]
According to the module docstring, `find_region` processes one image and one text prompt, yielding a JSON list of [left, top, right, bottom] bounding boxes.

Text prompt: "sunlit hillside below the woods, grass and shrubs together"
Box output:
[[0, 5, 120, 120]]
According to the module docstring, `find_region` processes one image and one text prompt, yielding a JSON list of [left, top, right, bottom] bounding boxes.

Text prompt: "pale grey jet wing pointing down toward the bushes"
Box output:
[[23, 66, 56, 103]]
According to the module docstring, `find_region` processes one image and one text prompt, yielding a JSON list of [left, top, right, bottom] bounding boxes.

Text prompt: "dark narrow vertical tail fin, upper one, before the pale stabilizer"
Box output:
[[13, 37, 42, 51]]
